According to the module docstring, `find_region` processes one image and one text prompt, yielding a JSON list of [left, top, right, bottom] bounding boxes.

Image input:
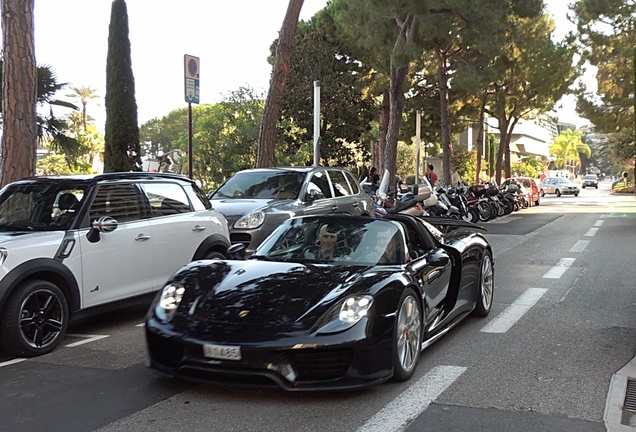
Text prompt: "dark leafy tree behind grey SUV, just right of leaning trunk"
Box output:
[[276, 22, 377, 167]]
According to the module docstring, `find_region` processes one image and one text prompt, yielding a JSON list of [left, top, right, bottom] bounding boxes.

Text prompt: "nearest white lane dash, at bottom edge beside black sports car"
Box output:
[[358, 366, 467, 432]]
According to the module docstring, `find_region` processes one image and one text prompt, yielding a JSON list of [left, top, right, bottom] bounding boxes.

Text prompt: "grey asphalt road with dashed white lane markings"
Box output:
[[0, 182, 636, 432]]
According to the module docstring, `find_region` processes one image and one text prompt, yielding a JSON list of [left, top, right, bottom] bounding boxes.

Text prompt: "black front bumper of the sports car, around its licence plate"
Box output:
[[146, 317, 394, 391]]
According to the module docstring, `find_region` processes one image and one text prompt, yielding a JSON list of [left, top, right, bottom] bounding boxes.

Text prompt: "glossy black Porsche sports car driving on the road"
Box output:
[[145, 214, 494, 390]]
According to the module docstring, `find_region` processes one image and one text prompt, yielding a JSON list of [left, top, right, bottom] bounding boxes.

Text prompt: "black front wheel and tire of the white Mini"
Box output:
[[1, 280, 69, 357]]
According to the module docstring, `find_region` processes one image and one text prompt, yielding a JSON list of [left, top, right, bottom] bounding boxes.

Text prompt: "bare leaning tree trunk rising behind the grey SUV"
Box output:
[[256, 0, 303, 168]]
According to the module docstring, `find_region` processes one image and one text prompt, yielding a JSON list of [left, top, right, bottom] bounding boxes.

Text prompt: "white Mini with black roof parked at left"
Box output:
[[0, 172, 230, 357]]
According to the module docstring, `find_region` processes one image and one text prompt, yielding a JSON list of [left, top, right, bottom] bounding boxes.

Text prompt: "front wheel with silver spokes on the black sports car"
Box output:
[[393, 289, 423, 381]]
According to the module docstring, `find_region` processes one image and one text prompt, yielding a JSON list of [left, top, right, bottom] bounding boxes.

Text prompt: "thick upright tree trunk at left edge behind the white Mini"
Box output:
[[0, 0, 38, 186]]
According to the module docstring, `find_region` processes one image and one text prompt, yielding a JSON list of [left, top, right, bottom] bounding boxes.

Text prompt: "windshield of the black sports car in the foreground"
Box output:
[[252, 216, 406, 266]]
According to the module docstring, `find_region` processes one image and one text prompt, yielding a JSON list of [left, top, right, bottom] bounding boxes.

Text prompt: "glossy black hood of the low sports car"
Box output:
[[175, 260, 380, 331]]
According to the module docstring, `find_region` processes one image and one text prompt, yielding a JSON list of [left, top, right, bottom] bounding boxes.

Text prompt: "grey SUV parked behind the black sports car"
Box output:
[[210, 166, 374, 256]]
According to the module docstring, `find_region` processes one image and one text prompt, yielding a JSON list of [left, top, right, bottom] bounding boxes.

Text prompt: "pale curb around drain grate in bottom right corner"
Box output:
[[603, 357, 636, 432]]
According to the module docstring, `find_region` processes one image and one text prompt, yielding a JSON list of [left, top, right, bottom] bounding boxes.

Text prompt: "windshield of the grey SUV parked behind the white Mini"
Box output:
[[212, 171, 305, 199]]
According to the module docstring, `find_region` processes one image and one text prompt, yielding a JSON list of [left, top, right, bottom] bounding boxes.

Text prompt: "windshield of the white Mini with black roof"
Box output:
[[0, 184, 85, 231]]
